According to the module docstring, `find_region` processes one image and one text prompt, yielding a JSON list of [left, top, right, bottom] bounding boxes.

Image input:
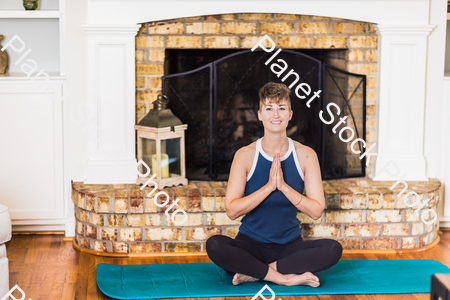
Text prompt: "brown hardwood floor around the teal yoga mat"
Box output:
[[6, 231, 450, 300]]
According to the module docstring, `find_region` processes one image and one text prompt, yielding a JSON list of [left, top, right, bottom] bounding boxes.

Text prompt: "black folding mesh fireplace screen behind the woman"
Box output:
[[162, 50, 366, 180]]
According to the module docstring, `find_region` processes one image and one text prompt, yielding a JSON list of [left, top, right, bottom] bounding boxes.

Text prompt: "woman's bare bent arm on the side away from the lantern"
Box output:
[[281, 147, 325, 220]]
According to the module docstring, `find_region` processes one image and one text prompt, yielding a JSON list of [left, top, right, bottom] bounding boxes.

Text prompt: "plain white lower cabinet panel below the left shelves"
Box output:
[[0, 81, 64, 220]]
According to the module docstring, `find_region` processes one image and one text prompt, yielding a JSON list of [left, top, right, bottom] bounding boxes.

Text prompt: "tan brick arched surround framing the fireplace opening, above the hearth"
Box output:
[[136, 13, 378, 175]]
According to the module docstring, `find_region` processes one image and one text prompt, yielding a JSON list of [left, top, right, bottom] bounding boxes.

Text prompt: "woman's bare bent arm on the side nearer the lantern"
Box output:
[[225, 148, 276, 220]]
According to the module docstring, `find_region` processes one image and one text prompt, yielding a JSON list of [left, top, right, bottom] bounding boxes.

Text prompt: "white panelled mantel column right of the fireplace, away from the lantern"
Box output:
[[371, 24, 435, 180]]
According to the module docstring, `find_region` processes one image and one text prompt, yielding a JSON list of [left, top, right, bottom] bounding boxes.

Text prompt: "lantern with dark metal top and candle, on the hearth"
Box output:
[[134, 94, 187, 189]]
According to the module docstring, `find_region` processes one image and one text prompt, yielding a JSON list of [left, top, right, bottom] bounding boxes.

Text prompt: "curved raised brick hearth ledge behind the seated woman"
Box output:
[[72, 178, 441, 255]]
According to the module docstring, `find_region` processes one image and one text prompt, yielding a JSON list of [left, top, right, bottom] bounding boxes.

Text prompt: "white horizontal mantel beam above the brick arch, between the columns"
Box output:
[[87, 0, 430, 24]]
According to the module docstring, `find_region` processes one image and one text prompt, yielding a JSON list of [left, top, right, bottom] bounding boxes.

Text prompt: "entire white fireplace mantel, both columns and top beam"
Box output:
[[83, 0, 434, 184]]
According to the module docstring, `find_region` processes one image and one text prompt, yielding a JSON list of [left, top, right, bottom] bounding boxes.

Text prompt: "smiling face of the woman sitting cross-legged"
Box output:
[[258, 99, 293, 131]]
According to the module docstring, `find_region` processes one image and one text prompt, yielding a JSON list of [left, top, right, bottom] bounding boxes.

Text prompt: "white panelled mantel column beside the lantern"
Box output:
[[81, 24, 140, 184]]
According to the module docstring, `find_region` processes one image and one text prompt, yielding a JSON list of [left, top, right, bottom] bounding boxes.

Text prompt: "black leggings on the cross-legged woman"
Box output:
[[206, 232, 342, 280]]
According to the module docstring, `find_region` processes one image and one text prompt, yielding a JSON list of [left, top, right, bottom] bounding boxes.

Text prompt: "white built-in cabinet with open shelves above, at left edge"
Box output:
[[0, 0, 67, 230]]
